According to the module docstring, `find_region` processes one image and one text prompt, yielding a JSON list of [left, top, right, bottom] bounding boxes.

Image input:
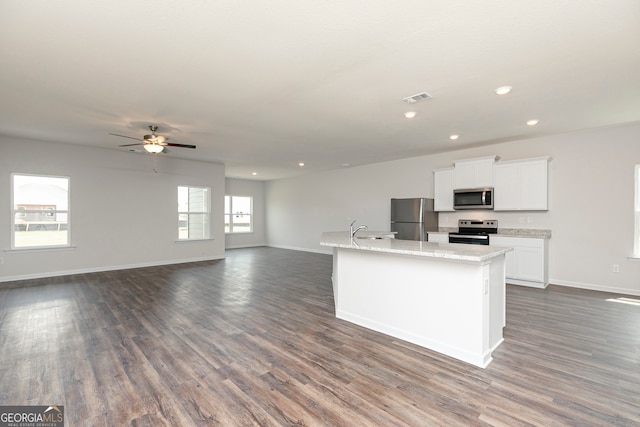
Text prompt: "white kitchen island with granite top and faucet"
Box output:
[[320, 231, 511, 368]]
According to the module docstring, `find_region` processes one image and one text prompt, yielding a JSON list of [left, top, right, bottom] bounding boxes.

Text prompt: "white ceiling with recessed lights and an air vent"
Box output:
[[0, 0, 640, 180]]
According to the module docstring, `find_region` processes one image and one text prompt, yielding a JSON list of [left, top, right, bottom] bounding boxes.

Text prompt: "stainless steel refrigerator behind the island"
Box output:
[[391, 198, 438, 241]]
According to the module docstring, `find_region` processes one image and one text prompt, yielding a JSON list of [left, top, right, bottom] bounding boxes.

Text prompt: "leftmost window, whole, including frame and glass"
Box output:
[[11, 174, 69, 249]]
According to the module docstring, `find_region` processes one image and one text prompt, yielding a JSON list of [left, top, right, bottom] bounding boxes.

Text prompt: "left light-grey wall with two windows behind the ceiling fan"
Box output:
[[0, 136, 225, 282]]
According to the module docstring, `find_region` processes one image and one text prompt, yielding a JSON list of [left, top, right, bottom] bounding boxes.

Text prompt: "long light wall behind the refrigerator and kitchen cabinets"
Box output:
[[265, 123, 640, 295]]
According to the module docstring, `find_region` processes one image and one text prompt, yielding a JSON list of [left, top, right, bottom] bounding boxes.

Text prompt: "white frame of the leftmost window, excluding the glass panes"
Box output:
[[9, 172, 72, 251]]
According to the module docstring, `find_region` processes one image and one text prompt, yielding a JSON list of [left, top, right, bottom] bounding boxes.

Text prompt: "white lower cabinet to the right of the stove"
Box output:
[[490, 236, 549, 288]]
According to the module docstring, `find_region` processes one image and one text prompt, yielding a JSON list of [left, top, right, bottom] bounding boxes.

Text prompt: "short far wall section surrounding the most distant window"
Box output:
[[225, 178, 266, 249]]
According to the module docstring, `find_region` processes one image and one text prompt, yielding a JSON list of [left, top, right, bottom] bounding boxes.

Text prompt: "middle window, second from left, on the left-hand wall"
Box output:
[[178, 186, 211, 240]]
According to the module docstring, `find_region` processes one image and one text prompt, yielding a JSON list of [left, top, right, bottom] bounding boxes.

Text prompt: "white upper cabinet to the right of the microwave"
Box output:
[[493, 157, 551, 211]]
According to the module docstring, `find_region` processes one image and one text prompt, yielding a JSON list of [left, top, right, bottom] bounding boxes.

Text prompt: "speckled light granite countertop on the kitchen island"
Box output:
[[320, 231, 512, 262]]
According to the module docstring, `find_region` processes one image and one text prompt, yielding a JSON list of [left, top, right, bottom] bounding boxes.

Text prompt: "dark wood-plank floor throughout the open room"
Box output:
[[0, 248, 640, 427]]
